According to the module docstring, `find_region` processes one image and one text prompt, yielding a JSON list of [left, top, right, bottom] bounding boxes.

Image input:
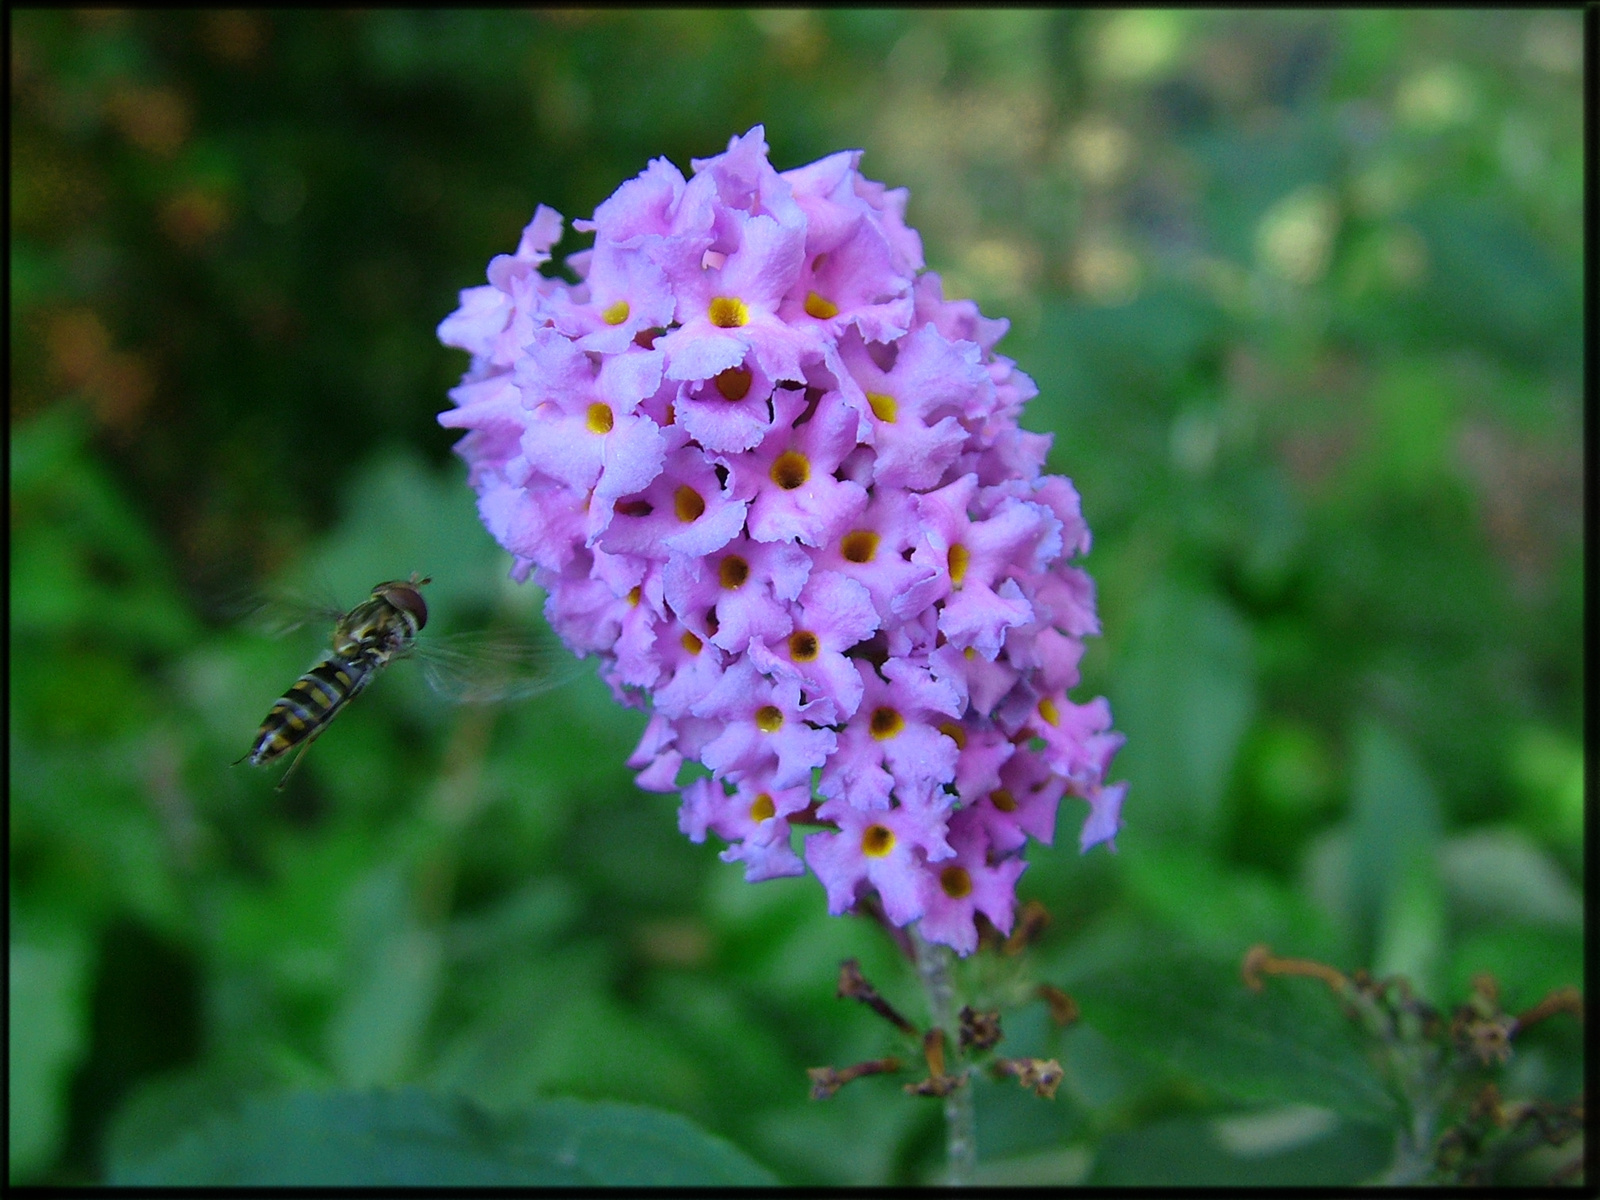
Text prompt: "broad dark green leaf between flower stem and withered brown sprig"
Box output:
[[1067, 952, 1394, 1122]]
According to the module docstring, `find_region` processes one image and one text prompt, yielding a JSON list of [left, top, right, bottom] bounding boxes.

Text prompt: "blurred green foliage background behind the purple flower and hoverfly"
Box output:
[[10, 10, 1584, 1184]]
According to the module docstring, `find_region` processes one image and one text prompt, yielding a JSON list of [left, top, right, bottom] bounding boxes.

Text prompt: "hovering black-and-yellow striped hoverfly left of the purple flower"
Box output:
[[234, 573, 576, 790]]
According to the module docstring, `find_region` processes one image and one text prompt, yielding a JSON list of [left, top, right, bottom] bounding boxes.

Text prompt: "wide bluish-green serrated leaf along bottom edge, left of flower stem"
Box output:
[[109, 1088, 776, 1187]]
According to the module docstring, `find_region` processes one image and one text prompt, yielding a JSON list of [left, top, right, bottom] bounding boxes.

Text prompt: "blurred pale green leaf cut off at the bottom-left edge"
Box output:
[[6, 938, 88, 1181]]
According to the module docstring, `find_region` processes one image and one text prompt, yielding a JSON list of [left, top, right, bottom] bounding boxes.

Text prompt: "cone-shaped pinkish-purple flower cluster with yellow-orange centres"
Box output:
[[438, 126, 1125, 954]]
